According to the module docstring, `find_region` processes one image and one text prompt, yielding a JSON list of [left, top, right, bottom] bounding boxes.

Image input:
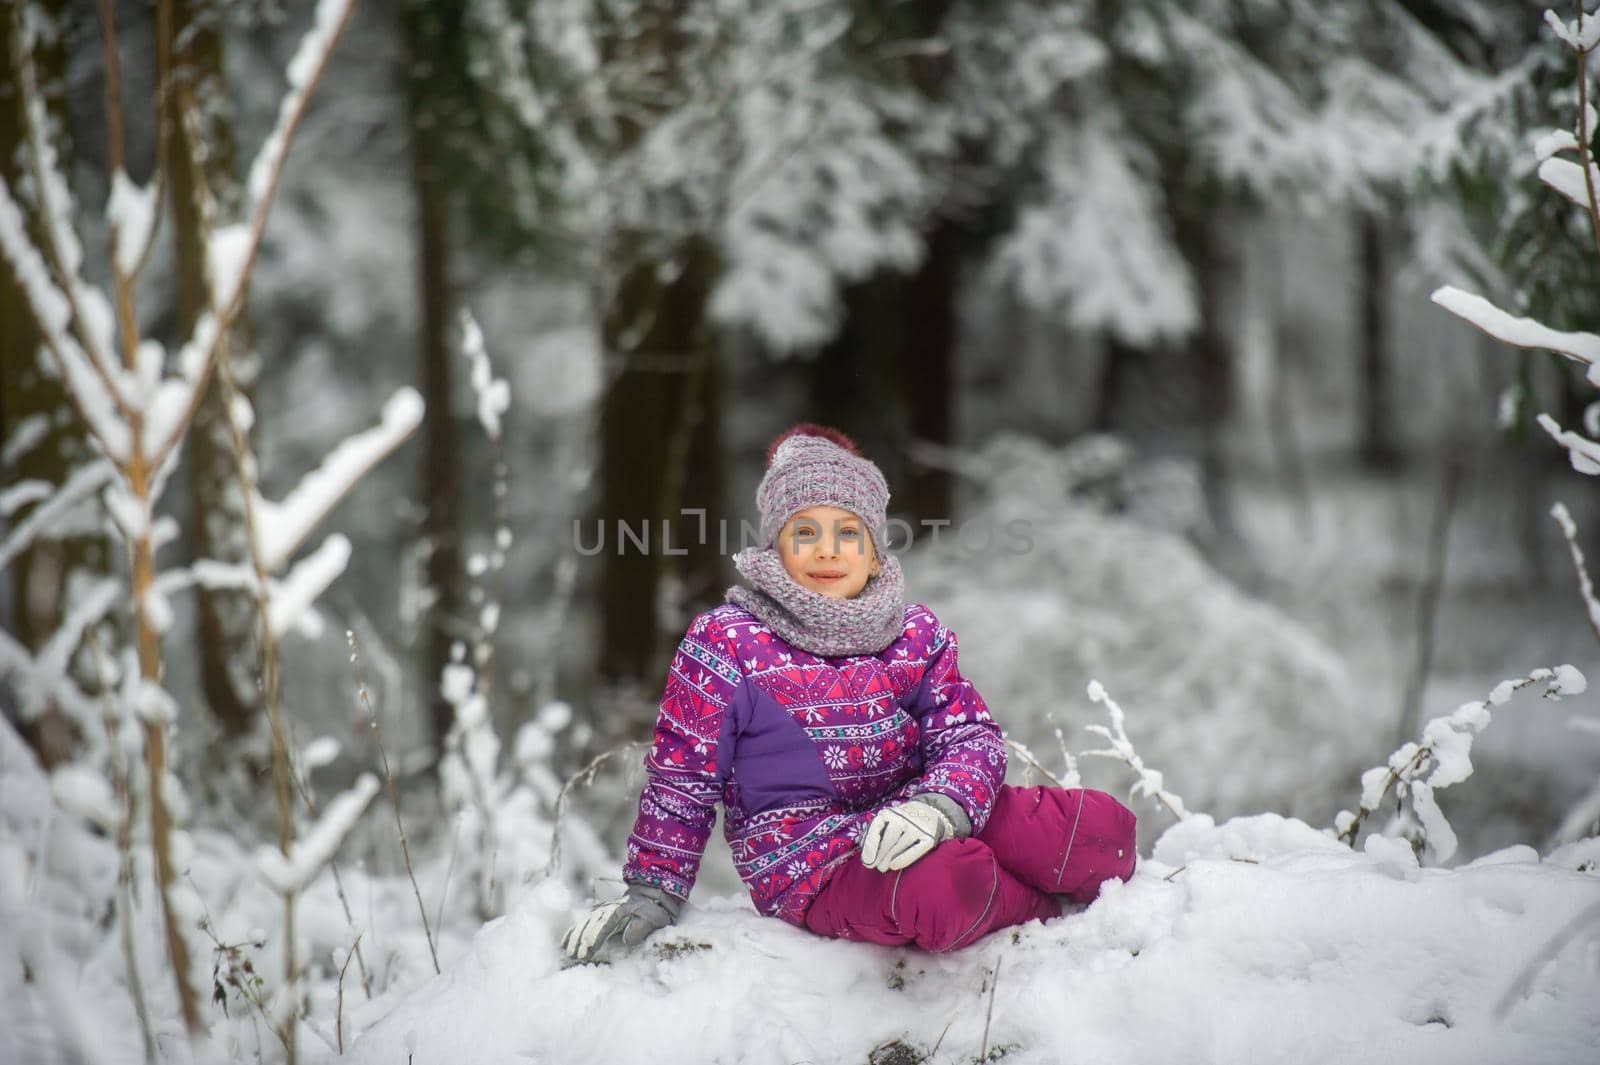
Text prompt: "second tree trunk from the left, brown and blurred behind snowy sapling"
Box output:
[[162, 0, 261, 736]]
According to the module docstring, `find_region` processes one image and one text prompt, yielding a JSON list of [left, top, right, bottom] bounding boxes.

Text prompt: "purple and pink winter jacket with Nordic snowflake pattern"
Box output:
[[622, 603, 1006, 926]]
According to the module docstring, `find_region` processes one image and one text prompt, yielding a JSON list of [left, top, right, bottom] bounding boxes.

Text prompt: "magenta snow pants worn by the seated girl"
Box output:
[[805, 785, 1138, 951]]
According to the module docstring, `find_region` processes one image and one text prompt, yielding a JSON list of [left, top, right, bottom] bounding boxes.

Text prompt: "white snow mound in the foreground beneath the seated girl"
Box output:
[[337, 814, 1600, 1065]]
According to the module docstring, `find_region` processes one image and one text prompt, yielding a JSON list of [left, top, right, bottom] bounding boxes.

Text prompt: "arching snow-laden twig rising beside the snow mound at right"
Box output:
[[1333, 665, 1589, 864]]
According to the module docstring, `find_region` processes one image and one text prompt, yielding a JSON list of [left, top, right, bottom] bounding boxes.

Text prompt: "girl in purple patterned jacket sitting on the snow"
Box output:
[[562, 424, 1138, 961]]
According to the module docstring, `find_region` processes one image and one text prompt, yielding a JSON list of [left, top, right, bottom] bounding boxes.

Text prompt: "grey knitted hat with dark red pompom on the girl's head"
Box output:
[[755, 422, 890, 552]]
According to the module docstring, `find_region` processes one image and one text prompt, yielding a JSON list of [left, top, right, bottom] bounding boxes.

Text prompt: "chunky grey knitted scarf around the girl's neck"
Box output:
[[728, 547, 906, 657]]
